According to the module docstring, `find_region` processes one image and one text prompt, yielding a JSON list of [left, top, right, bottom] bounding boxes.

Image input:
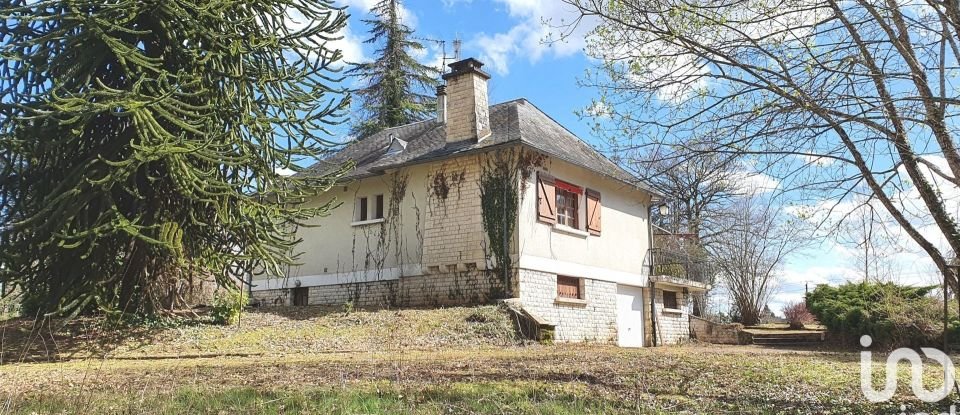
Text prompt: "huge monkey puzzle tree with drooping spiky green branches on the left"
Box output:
[[0, 0, 346, 313]]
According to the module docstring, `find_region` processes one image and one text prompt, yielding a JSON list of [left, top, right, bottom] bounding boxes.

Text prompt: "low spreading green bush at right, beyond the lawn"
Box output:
[[807, 283, 960, 348]]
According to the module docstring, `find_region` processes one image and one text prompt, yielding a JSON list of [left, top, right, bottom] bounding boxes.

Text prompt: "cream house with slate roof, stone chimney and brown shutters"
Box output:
[[252, 59, 705, 346]]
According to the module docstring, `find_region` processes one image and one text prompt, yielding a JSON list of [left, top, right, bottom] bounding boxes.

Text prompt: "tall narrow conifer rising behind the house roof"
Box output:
[[348, 0, 440, 138]]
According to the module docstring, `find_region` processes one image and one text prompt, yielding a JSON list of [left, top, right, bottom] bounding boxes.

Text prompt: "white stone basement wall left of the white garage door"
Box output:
[[518, 269, 617, 342]]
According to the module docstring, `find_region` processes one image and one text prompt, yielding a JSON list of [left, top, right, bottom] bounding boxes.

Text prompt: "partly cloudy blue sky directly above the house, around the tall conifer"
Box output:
[[334, 0, 595, 139]]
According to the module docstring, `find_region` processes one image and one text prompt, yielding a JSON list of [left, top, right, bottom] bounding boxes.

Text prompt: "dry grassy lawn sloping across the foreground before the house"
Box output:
[[0, 308, 949, 414]]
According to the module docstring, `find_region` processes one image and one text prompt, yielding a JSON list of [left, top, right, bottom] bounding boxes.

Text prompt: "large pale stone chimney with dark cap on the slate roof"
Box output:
[[438, 58, 490, 144]]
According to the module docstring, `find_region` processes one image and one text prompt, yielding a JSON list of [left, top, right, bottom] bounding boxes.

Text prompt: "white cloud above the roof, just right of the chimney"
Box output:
[[468, 0, 593, 75]]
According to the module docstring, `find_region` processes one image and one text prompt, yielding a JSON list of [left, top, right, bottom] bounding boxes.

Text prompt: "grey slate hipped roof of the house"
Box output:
[[301, 98, 659, 194]]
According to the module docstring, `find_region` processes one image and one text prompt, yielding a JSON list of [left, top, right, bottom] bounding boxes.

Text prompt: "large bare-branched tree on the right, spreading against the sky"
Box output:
[[565, 0, 960, 289]]
